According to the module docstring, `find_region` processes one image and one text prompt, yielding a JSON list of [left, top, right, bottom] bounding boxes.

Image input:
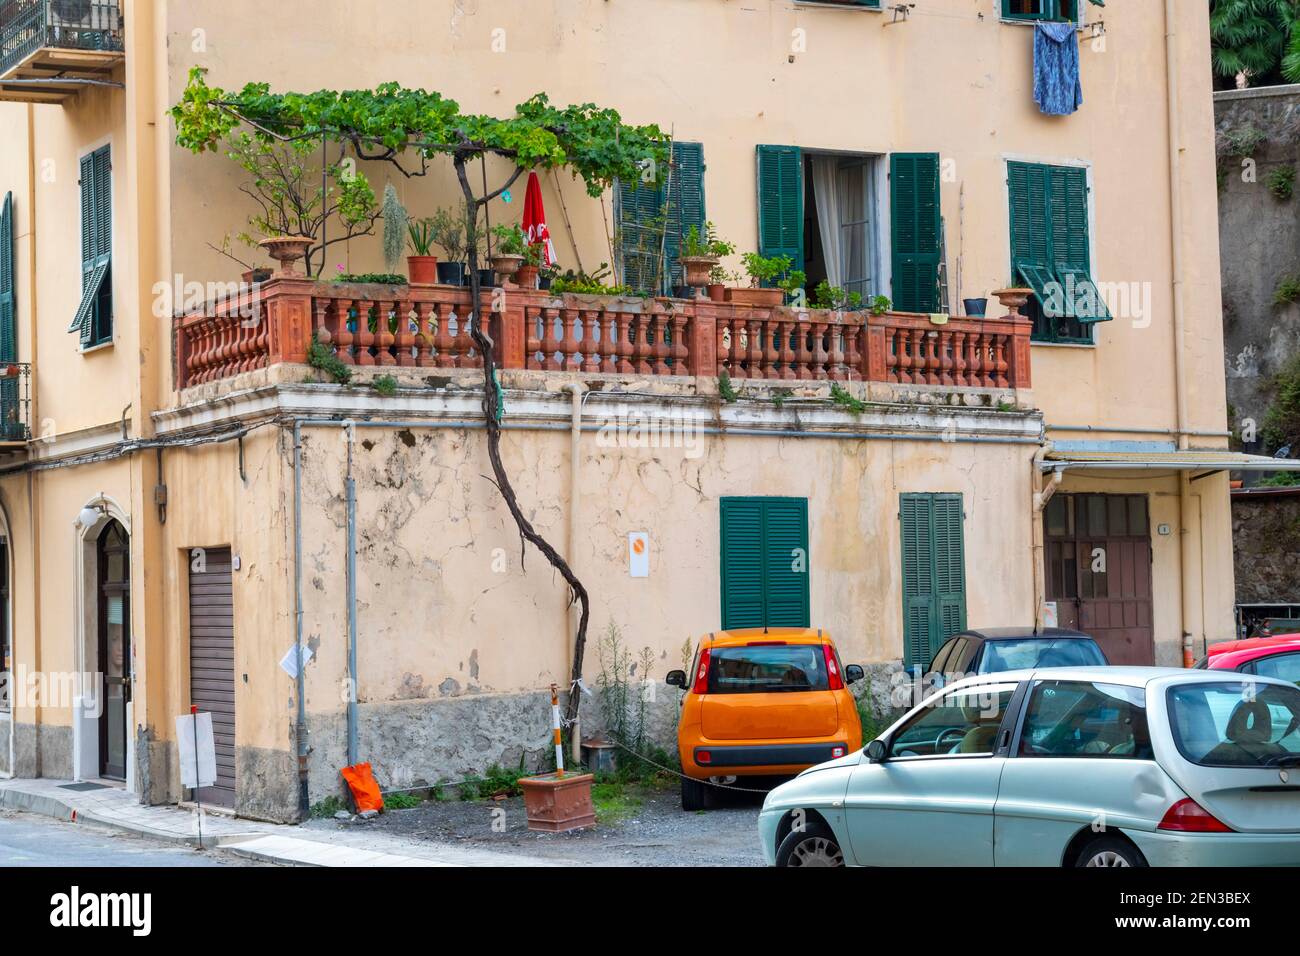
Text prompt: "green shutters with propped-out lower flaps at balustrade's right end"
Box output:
[[1006, 163, 1110, 343]]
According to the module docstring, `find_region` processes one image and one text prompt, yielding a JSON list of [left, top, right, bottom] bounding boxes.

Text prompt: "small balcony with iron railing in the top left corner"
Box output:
[[0, 0, 125, 103]]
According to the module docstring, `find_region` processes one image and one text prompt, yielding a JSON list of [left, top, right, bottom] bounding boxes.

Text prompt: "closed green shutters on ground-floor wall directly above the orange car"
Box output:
[[720, 498, 810, 630]]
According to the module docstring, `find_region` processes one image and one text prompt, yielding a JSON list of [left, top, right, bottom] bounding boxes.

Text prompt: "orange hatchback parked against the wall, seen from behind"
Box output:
[[667, 627, 863, 810]]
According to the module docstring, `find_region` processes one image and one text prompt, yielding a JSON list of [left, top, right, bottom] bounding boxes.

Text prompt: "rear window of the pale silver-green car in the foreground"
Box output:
[[1169, 680, 1300, 767]]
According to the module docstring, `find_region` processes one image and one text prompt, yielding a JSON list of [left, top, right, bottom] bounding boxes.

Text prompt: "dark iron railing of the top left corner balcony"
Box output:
[[0, 0, 124, 77]]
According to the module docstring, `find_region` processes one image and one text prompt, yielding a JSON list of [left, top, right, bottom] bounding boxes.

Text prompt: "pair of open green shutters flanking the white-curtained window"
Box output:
[[758, 146, 943, 312]]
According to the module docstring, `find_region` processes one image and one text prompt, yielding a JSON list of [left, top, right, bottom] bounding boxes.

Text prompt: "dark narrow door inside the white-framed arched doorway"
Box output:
[[95, 520, 131, 780]]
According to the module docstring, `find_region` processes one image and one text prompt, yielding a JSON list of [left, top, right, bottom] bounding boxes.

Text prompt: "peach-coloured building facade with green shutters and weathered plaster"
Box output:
[[0, 0, 1232, 819]]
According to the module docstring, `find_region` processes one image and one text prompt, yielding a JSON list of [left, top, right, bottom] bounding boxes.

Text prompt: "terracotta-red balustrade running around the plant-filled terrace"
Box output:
[[174, 277, 1031, 389]]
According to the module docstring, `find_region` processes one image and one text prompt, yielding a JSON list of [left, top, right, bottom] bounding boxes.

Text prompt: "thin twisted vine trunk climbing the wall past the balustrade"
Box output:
[[454, 152, 592, 727]]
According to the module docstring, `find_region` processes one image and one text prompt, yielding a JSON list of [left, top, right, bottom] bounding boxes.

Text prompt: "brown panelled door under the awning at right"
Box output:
[[1044, 494, 1156, 665]]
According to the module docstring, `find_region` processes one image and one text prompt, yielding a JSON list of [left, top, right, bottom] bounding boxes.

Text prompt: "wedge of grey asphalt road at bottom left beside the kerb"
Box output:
[[0, 812, 250, 868]]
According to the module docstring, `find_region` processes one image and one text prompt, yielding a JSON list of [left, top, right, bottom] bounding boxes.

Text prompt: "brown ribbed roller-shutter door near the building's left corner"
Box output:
[[190, 548, 235, 808]]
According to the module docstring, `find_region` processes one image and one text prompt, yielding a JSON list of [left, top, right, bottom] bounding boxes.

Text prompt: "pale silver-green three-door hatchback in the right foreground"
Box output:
[[758, 667, 1300, 866]]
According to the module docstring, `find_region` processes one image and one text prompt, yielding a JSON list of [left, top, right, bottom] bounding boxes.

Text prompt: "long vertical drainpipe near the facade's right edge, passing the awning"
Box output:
[[1165, 0, 1204, 667]]
